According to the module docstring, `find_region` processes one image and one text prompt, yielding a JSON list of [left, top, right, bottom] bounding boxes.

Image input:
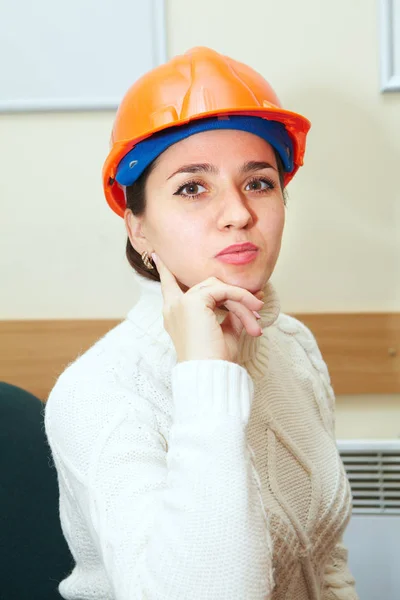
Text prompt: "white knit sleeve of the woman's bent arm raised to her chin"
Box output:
[[45, 360, 273, 600]]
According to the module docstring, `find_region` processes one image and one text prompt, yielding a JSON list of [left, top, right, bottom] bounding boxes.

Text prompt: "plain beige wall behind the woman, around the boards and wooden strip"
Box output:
[[0, 0, 400, 437]]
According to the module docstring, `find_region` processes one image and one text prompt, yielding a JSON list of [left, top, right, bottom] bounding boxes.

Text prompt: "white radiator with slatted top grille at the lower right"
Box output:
[[337, 440, 400, 600]]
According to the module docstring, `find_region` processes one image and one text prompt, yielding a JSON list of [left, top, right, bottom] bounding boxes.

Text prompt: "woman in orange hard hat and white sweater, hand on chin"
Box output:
[[46, 48, 357, 600]]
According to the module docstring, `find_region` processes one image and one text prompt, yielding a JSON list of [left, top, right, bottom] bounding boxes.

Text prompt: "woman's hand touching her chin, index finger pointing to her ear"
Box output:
[[152, 254, 263, 362]]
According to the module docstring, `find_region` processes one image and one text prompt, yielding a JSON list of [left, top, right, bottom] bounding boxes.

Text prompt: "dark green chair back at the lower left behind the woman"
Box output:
[[0, 382, 73, 600]]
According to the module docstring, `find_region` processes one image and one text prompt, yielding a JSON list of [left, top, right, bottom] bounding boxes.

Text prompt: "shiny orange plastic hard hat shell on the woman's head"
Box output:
[[103, 47, 311, 216]]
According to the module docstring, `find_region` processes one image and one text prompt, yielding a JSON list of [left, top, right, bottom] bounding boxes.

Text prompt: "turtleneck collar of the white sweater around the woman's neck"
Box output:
[[127, 273, 280, 377]]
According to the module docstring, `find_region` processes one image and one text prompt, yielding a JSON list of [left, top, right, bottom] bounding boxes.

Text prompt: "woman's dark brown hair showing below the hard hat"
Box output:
[[126, 149, 287, 281]]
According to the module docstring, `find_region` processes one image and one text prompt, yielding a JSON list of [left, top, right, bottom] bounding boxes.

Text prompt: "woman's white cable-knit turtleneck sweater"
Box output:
[[45, 276, 358, 600]]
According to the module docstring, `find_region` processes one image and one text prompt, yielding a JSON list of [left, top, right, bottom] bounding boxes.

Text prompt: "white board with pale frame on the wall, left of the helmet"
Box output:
[[0, 0, 166, 112]]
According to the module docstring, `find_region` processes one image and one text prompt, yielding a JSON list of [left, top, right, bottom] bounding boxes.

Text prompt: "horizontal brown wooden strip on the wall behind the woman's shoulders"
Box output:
[[0, 313, 400, 400]]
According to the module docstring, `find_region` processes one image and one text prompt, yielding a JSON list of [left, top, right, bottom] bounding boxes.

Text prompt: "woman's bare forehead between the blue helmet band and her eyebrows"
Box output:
[[158, 129, 276, 167]]
